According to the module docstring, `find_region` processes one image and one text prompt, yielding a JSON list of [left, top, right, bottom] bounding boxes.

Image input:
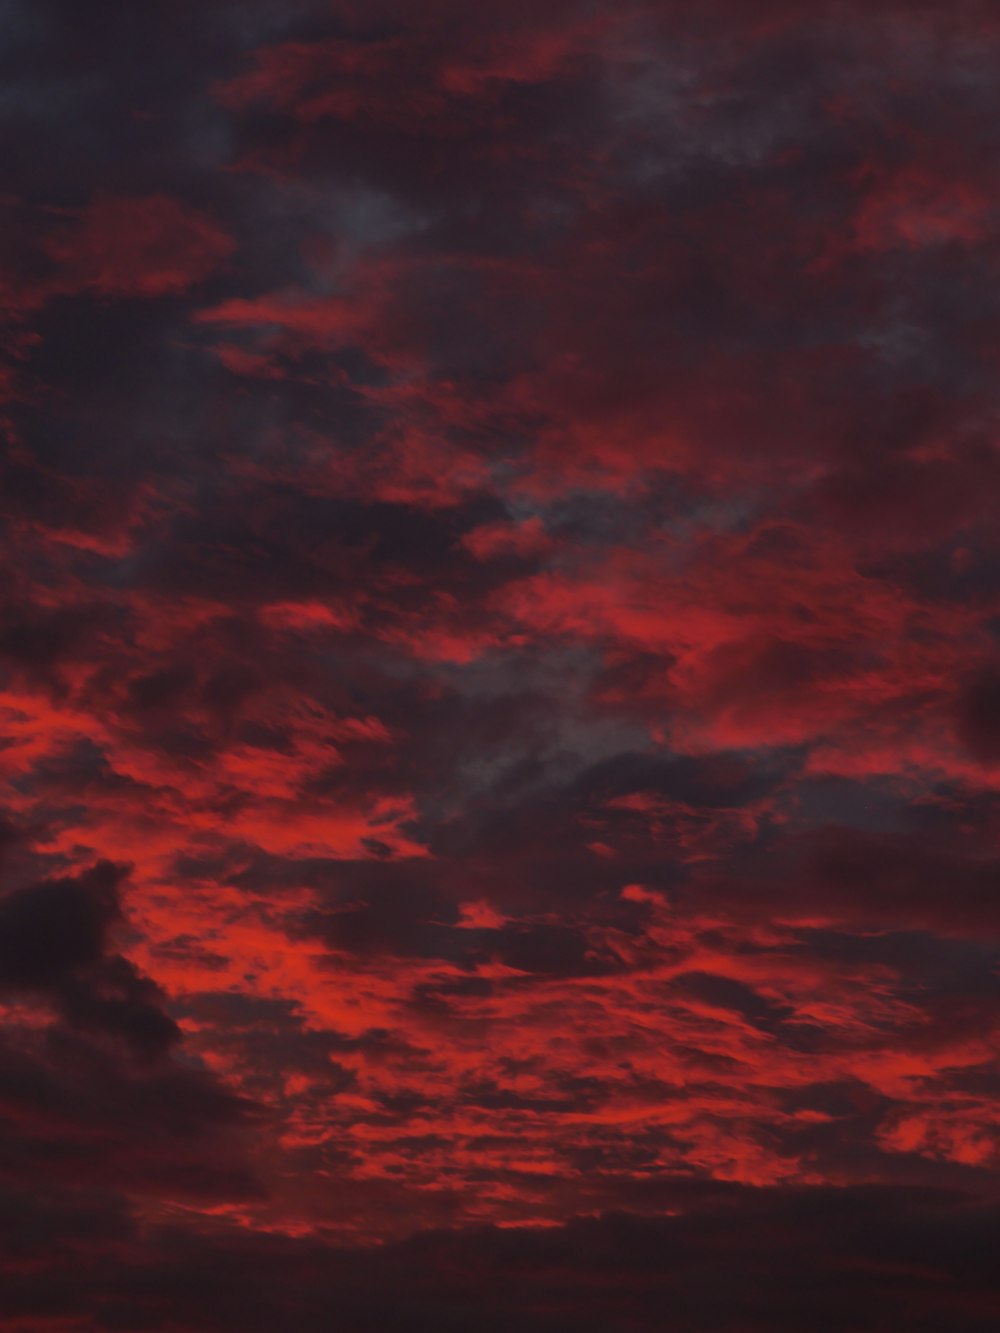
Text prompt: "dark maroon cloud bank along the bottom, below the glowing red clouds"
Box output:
[[1, 1182, 996, 1333]]
